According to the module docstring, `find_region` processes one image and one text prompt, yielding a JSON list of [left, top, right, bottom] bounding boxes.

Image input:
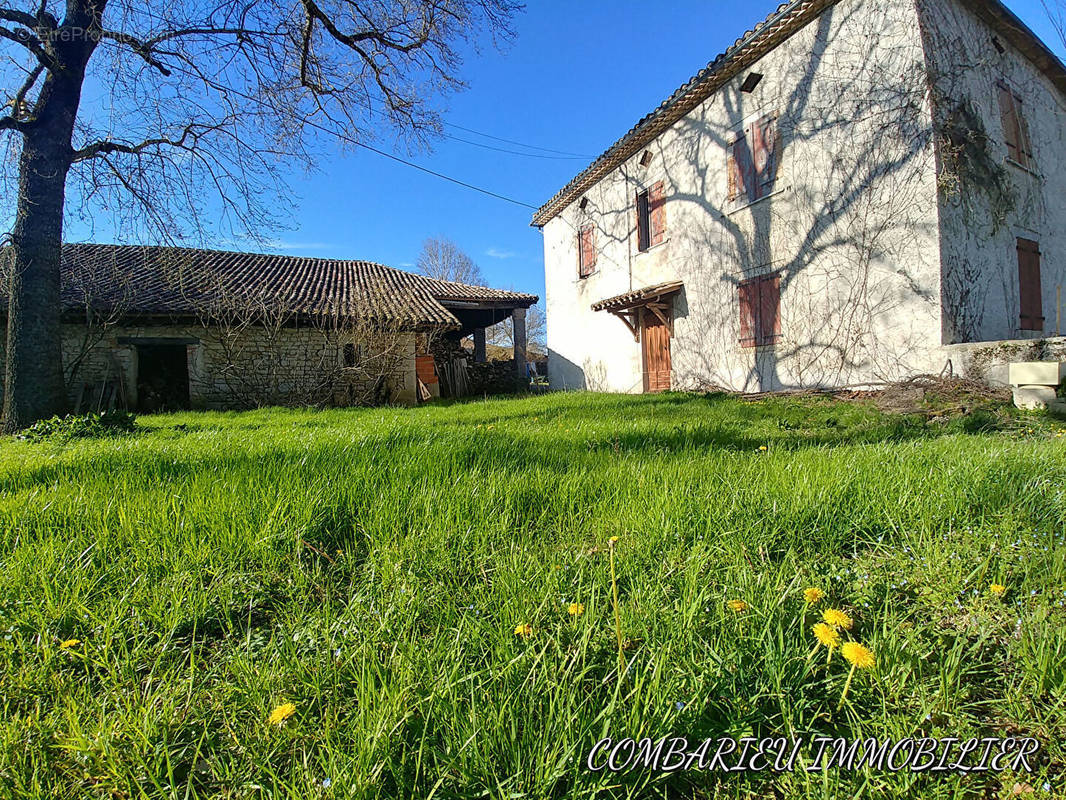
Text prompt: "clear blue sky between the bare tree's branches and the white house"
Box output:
[[68, 0, 1062, 297]]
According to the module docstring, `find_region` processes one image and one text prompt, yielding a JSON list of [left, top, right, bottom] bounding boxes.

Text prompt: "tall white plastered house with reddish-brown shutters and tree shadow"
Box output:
[[533, 0, 1066, 391]]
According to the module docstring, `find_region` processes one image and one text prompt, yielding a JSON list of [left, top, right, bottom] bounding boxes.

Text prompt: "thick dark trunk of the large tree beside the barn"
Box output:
[[3, 140, 68, 433]]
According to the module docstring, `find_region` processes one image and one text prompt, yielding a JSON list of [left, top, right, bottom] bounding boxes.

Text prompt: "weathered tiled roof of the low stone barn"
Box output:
[[41, 244, 537, 330]]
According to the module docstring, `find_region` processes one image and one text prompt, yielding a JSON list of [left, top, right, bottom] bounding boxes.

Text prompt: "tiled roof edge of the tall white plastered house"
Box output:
[[532, 0, 1066, 227]]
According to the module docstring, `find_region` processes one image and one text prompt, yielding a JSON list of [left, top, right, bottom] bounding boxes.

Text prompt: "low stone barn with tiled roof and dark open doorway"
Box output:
[[0, 244, 537, 411]]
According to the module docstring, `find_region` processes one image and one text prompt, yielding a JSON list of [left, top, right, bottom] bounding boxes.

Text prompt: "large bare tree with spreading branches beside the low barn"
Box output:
[[0, 0, 520, 431]]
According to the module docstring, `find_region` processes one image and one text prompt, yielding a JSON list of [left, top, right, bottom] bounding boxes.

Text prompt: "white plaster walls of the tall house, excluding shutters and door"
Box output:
[[535, 0, 1066, 391]]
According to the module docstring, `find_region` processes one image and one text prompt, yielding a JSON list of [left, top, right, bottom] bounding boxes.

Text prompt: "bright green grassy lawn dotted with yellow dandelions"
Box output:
[[0, 395, 1066, 799]]
